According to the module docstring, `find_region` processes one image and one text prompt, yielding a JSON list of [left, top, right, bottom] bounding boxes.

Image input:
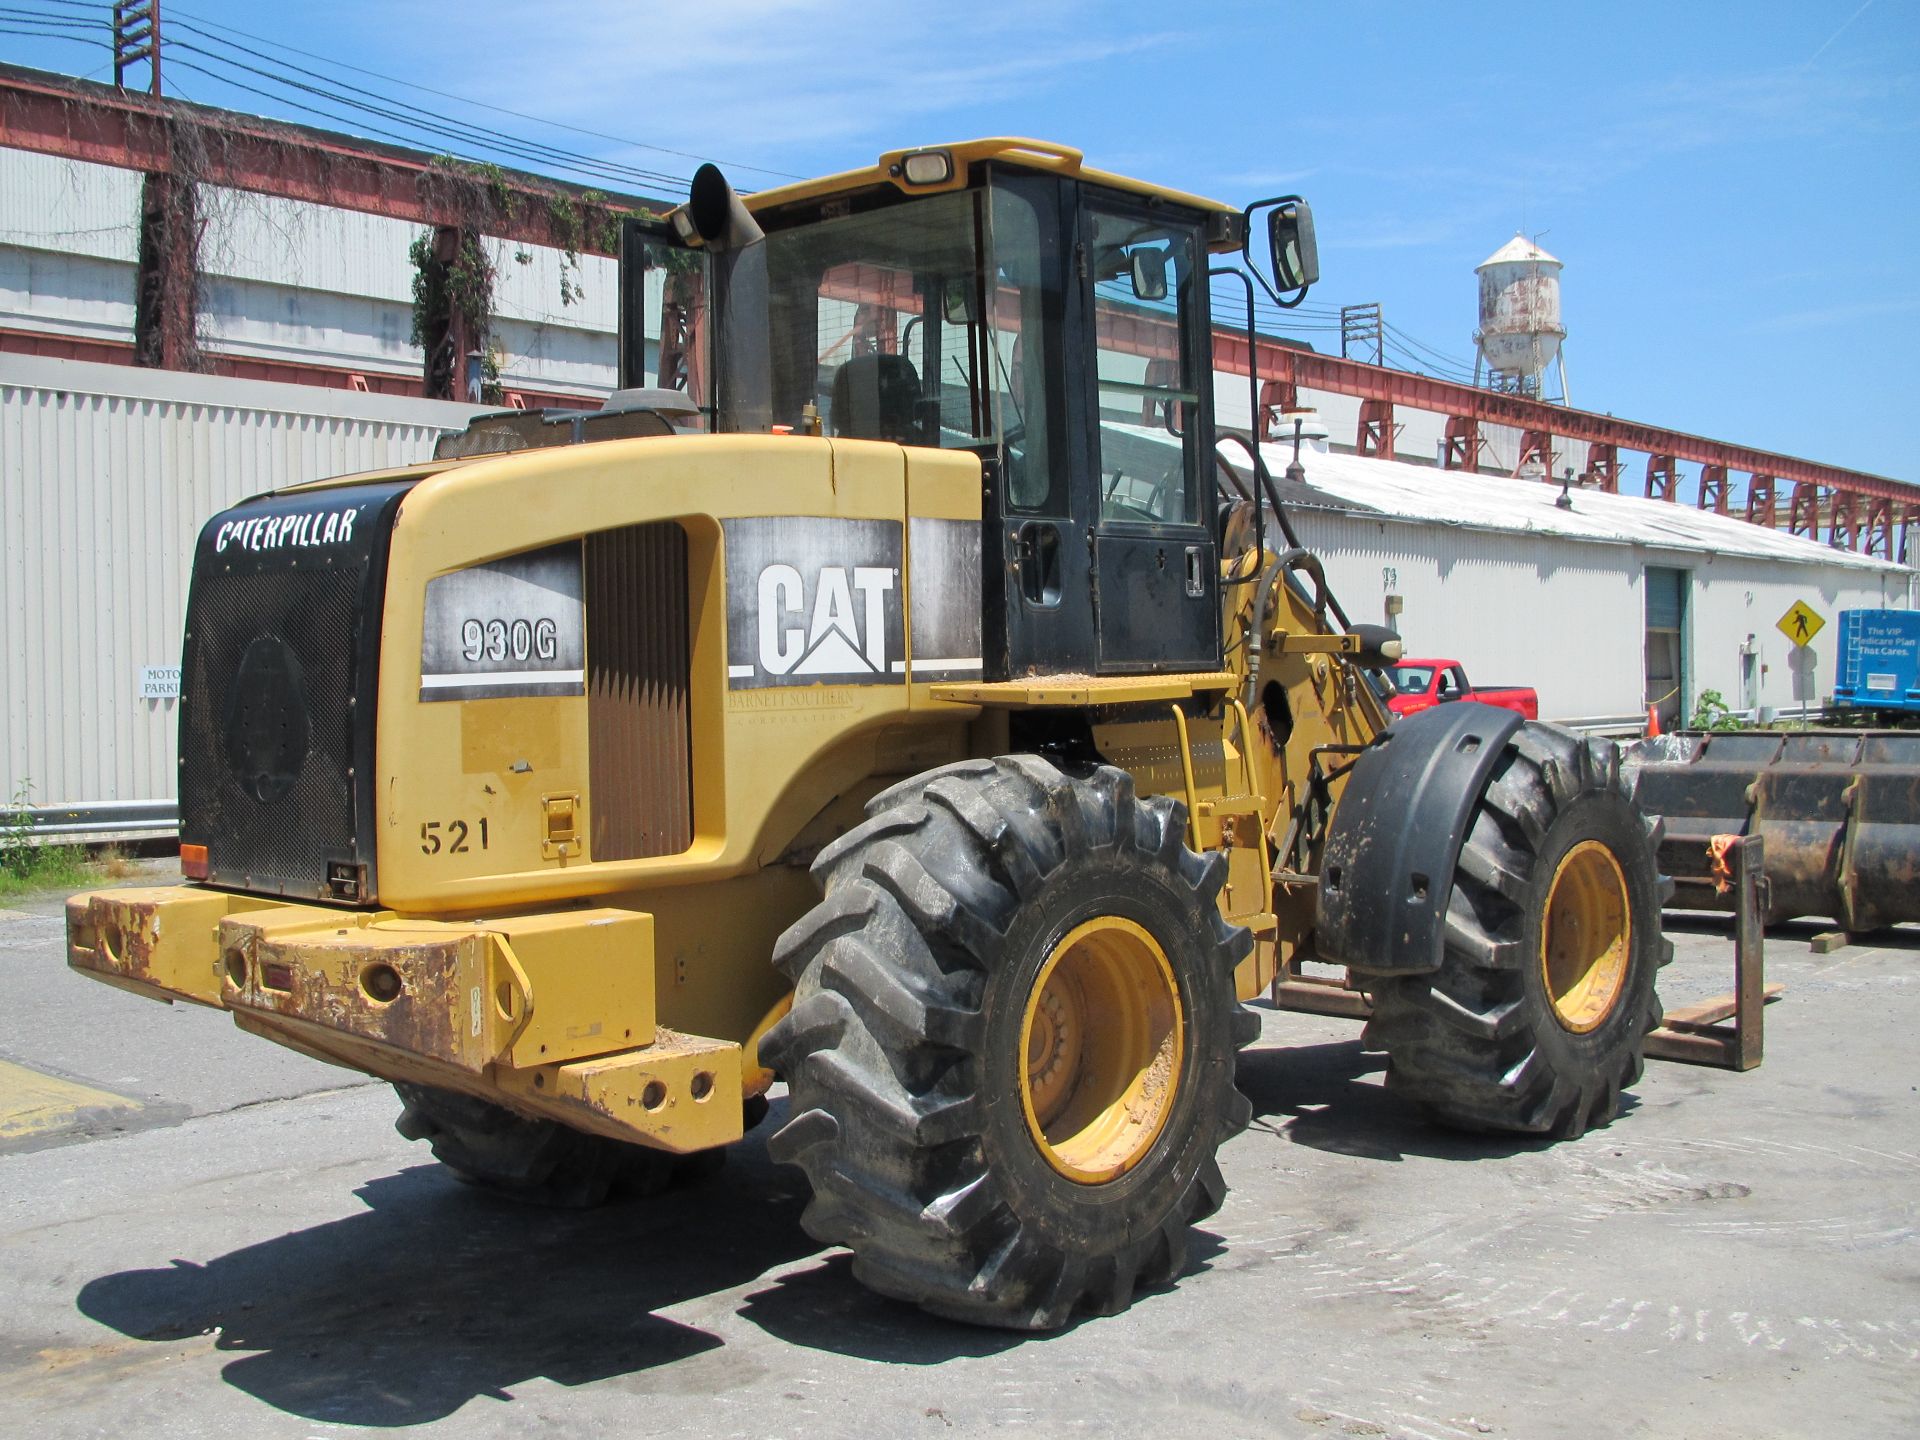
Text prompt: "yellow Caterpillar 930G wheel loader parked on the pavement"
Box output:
[[67, 140, 1663, 1327]]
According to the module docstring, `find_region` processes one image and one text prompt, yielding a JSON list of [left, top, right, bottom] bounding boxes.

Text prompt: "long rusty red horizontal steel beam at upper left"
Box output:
[[0, 65, 659, 255]]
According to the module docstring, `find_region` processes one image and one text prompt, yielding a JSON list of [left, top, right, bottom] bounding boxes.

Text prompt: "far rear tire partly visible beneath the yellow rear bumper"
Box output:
[[394, 1085, 691, 1210]]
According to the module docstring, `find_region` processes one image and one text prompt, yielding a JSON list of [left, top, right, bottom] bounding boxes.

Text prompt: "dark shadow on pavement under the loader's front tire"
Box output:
[[1229, 1039, 1566, 1179]]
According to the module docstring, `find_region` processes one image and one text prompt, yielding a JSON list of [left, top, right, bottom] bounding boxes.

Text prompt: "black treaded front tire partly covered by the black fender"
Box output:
[[1357, 722, 1672, 1139]]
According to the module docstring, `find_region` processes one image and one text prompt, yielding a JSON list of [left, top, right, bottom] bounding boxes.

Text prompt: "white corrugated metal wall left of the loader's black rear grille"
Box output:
[[0, 353, 476, 804]]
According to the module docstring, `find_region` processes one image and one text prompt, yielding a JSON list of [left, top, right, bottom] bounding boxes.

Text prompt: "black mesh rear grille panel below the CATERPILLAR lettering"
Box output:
[[180, 566, 372, 897]]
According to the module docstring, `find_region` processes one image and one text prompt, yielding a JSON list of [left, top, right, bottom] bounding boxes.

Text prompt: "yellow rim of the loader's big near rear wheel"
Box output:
[[1020, 916, 1185, 1185]]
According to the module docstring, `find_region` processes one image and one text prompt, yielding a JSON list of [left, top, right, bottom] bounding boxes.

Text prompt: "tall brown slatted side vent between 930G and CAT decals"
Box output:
[[586, 520, 693, 860]]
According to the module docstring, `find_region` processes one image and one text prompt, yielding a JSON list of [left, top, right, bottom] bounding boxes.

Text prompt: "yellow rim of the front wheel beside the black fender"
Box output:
[[1540, 841, 1634, 1035]]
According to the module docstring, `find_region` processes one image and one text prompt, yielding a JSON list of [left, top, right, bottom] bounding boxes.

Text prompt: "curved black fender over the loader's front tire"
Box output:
[[1315, 701, 1523, 975]]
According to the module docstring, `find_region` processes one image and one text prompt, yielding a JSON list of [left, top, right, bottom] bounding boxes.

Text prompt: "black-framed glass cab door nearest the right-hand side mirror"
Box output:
[[1077, 190, 1219, 674]]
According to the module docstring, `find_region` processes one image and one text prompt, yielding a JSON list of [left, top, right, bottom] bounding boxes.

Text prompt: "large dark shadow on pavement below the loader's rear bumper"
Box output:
[[77, 1140, 814, 1427]]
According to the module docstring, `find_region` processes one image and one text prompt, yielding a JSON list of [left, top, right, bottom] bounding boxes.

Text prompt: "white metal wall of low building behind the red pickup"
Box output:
[[1294, 509, 1908, 724]]
